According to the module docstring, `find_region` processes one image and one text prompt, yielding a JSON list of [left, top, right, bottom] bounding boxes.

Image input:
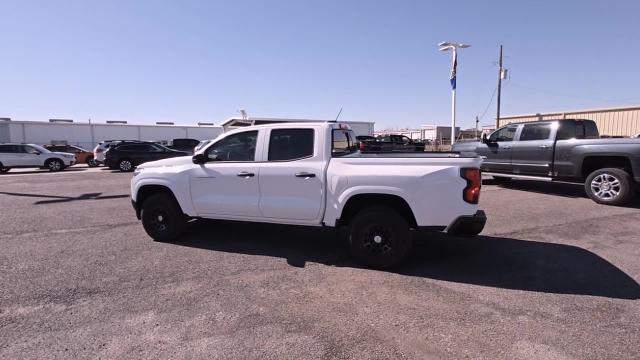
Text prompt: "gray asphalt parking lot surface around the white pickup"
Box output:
[[0, 167, 640, 359]]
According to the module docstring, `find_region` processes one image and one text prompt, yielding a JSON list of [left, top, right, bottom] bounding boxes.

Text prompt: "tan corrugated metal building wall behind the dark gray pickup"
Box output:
[[500, 106, 640, 136]]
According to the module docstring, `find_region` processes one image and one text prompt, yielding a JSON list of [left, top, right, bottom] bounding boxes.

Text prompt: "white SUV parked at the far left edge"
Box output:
[[0, 144, 76, 174]]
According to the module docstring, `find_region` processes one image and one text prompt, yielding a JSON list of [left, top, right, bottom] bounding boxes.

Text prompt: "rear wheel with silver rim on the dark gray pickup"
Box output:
[[584, 168, 634, 205]]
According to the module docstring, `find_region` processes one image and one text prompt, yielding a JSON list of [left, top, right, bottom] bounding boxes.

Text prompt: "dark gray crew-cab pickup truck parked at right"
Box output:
[[452, 119, 640, 205]]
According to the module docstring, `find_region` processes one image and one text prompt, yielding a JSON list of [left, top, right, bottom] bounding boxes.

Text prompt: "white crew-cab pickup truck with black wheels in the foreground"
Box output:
[[131, 122, 486, 268]]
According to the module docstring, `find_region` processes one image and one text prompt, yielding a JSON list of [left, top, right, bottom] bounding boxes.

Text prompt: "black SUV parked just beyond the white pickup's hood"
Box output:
[[104, 141, 190, 171]]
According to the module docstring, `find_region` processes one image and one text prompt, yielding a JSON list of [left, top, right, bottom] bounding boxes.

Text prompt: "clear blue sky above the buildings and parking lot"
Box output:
[[0, 0, 640, 128]]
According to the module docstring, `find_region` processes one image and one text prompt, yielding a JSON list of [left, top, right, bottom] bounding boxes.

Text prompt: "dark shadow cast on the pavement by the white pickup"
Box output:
[[174, 221, 640, 300]]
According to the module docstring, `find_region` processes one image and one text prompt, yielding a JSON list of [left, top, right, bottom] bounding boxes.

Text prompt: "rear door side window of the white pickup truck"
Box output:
[[269, 129, 314, 161]]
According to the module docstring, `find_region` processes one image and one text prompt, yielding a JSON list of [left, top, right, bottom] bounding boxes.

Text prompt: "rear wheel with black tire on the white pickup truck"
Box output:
[[349, 206, 413, 269]]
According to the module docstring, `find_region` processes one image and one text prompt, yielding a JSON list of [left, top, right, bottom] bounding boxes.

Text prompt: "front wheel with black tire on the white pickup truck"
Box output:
[[140, 194, 187, 242]]
